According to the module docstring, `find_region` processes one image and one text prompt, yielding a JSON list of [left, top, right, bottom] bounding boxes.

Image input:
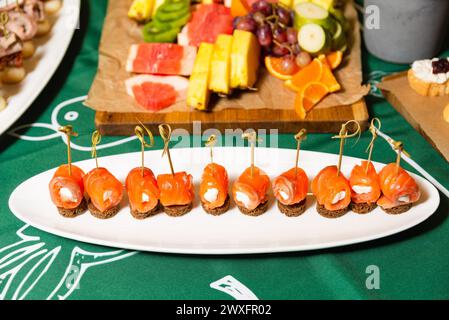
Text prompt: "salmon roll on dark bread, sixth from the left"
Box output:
[[232, 167, 270, 216]]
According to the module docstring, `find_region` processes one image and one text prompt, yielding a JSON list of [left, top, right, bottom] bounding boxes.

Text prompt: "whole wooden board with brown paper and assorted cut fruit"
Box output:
[[85, 0, 369, 134]]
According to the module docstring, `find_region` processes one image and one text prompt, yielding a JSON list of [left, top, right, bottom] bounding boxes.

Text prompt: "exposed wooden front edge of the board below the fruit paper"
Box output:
[[95, 99, 369, 135]]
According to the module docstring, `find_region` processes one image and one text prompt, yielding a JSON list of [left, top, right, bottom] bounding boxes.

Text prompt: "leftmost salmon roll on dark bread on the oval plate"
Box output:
[[49, 164, 87, 218]]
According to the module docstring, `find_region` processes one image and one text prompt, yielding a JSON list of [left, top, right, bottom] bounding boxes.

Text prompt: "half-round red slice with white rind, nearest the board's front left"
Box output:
[[125, 75, 189, 111]]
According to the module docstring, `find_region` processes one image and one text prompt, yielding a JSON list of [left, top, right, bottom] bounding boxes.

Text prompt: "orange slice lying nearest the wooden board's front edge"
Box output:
[[295, 82, 329, 119]]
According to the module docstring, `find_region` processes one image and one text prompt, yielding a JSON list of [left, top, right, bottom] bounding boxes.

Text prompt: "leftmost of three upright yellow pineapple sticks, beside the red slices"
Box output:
[[187, 42, 214, 110]]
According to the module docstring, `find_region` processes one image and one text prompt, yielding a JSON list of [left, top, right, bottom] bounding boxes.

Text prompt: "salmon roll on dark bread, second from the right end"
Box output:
[[349, 161, 381, 214]]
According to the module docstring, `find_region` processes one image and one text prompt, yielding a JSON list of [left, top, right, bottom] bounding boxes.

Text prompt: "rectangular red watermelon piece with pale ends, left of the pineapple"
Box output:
[[126, 43, 196, 76]]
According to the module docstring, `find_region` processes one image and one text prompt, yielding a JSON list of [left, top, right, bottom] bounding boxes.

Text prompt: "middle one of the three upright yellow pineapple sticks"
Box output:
[[209, 34, 232, 94]]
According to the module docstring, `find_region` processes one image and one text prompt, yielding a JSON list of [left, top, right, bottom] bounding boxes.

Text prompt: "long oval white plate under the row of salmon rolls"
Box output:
[[9, 148, 440, 254]]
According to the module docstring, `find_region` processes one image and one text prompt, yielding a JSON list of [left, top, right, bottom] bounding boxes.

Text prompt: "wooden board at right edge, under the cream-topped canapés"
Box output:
[[378, 72, 449, 161]]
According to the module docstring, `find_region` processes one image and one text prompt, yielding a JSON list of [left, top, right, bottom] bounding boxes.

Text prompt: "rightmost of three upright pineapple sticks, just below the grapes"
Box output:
[[231, 30, 260, 89]]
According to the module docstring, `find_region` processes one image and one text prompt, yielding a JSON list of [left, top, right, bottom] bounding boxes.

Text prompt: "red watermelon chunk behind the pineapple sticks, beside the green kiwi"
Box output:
[[178, 3, 233, 47]]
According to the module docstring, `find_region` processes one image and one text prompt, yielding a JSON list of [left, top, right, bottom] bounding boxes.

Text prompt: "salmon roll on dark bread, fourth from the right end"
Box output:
[[273, 168, 309, 217]]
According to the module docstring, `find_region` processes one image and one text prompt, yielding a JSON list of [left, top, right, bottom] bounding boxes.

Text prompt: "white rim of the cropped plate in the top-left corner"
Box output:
[[0, 0, 80, 134]]
